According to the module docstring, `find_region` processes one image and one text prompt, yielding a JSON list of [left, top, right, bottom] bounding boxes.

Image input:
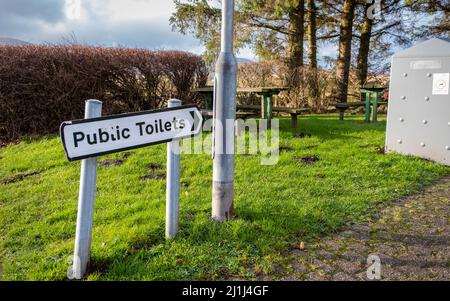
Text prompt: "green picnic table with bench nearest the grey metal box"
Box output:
[[334, 86, 387, 123]]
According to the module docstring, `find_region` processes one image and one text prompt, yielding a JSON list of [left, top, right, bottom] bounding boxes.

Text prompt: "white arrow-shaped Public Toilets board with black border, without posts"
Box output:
[[60, 105, 203, 161]]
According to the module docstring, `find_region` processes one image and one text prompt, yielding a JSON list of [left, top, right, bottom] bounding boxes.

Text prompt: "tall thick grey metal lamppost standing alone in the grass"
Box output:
[[212, 0, 237, 222]]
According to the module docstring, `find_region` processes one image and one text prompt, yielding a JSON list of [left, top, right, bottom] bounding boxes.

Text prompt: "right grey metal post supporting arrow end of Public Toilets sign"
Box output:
[[166, 99, 181, 239]]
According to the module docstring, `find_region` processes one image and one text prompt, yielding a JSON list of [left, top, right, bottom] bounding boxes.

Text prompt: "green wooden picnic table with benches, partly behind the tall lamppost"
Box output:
[[195, 86, 310, 128]]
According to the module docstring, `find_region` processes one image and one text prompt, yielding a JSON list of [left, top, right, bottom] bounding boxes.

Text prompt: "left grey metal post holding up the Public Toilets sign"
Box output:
[[72, 99, 102, 279]]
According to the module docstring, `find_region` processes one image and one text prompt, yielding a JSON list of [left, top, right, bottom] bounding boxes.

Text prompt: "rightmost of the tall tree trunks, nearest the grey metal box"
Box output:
[[356, 4, 373, 87]]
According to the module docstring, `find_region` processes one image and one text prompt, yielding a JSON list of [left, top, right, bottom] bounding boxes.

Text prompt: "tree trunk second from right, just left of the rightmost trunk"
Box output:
[[336, 0, 356, 102]]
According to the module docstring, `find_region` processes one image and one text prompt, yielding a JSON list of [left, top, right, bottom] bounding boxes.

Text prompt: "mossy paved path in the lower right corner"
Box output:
[[264, 176, 450, 280]]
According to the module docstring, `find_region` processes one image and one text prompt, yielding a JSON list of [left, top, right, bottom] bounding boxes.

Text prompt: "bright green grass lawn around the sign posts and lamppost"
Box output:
[[0, 116, 450, 280]]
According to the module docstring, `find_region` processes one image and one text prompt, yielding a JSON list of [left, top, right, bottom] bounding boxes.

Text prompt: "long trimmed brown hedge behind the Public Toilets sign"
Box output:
[[0, 45, 208, 142]]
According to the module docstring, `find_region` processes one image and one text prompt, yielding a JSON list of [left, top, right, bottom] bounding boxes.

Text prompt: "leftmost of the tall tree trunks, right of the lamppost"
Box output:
[[287, 0, 305, 87]]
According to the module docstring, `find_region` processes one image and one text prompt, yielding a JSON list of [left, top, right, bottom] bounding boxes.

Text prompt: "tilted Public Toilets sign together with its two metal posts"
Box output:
[[60, 99, 203, 279]]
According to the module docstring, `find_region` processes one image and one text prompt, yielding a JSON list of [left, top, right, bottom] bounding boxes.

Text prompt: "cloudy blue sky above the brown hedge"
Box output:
[[0, 0, 254, 59]]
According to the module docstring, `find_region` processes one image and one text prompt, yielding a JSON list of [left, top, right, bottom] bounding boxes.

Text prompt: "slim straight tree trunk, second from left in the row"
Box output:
[[307, 0, 319, 107]]
